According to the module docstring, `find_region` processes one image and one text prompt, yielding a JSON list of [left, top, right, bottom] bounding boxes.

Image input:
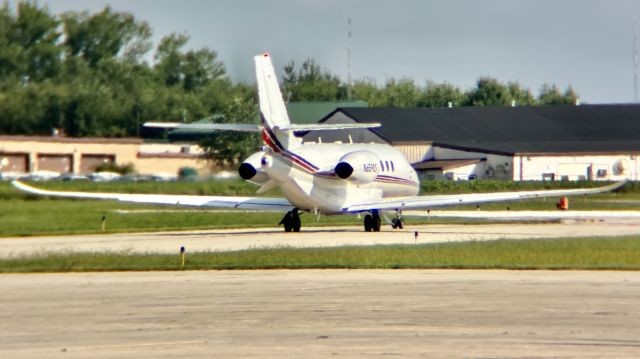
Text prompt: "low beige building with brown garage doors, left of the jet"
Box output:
[[0, 136, 210, 175]]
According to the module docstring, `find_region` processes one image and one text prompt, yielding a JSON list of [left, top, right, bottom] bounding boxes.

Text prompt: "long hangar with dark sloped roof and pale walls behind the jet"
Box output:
[[303, 105, 640, 181]]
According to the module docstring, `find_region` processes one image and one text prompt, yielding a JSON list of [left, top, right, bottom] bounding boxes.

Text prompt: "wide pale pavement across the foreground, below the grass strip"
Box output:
[[0, 270, 640, 359]]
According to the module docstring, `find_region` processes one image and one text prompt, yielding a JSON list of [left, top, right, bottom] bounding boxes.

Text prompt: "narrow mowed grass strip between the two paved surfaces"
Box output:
[[0, 237, 640, 273]]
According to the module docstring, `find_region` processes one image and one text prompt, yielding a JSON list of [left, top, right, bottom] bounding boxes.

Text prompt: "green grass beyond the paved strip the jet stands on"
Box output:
[[0, 180, 640, 236]]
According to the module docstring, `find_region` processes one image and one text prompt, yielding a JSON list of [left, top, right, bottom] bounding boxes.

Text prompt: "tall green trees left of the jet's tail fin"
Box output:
[[0, 2, 255, 141]]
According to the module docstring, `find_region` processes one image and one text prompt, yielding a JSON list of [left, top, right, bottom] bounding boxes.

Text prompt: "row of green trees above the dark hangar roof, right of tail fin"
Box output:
[[283, 59, 579, 107]]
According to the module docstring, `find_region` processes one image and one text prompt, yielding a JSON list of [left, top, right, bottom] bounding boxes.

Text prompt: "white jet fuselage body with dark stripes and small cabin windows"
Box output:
[[262, 141, 419, 214]]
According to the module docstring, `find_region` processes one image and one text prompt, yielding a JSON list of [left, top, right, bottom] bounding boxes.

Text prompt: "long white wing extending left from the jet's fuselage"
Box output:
[[11, 181, 293, 211]]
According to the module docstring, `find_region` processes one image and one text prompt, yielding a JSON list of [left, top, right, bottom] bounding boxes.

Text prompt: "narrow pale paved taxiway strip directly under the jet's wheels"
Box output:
[[0, 218, 640, 258]]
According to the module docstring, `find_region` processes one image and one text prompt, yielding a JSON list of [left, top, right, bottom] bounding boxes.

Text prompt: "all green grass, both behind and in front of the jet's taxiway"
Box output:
[[0, 180, 640, 272]]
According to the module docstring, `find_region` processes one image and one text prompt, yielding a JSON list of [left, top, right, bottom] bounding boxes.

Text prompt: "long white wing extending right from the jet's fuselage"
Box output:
[[343, 181, 627, 213]]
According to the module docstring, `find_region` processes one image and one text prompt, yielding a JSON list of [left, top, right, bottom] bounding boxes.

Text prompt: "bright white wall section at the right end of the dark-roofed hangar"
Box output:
[[514, 154, 640, 181]]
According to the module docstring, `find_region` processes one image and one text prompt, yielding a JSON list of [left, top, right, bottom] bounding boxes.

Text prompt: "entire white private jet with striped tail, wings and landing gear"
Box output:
[[13, 53, 624, 232]]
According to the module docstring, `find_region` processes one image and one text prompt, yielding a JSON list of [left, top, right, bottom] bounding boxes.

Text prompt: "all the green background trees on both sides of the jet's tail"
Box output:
[[0, 1, 578, 160]]
